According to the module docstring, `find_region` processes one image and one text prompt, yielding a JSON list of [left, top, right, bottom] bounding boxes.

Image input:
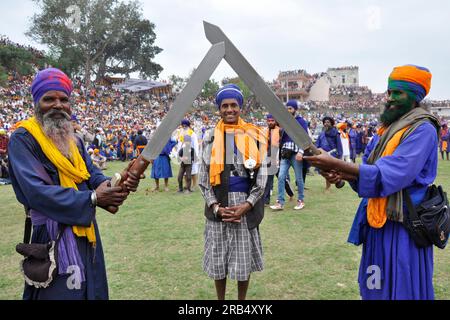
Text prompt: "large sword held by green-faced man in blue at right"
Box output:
[[203, 21, 345, 188]]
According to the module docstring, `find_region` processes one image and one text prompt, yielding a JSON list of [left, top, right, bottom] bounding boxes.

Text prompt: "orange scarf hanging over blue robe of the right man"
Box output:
[[367, 126, 410, 228]]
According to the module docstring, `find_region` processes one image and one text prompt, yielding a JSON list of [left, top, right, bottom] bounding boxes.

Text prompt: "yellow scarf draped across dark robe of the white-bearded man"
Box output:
[[18, 117, 96, 245]]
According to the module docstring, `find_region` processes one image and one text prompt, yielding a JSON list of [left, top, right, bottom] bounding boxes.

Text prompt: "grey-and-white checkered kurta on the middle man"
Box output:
[[199, 129, 267, 281]]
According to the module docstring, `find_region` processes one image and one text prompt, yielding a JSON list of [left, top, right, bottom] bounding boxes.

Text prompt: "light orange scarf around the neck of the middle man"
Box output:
[[209, 118, 267, 186]]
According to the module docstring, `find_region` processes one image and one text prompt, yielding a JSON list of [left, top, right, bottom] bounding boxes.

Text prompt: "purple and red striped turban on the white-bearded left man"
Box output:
[[31, 68, 73, 106]]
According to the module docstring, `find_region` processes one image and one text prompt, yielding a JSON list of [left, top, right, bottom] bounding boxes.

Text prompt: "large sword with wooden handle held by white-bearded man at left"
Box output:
[[106, 41, 225, 213]]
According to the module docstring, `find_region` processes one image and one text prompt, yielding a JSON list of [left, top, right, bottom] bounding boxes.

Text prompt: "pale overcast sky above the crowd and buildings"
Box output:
[[0, 0, 450, 99]]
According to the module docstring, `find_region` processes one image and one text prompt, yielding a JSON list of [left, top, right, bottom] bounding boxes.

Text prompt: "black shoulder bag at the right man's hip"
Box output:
[[403, 185, 450, 249]]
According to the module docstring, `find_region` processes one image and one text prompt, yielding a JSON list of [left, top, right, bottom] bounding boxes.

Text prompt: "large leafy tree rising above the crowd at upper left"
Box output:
[[27, 0, 162, 87]]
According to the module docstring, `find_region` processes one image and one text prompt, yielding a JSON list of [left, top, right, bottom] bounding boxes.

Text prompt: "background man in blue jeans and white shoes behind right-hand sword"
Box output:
[[270, 100, 308, 211]]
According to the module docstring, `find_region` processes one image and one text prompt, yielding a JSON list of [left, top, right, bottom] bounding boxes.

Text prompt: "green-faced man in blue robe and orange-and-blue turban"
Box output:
[[307, 65, 440, 300]]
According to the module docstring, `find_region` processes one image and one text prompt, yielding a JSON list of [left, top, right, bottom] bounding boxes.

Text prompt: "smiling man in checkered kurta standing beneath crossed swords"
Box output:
[[199, 84, 267, 300]]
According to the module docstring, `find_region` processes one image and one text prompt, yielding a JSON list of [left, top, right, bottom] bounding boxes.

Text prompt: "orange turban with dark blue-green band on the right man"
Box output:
[[388, 65, 431, 102]]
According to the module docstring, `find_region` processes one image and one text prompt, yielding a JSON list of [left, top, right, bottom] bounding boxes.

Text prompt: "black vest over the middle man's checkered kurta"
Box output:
[[205, 134, 264, 230]]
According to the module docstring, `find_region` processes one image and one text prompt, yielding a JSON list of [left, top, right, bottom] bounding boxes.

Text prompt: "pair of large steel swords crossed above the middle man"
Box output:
[[107, 21, 344, 213]]
